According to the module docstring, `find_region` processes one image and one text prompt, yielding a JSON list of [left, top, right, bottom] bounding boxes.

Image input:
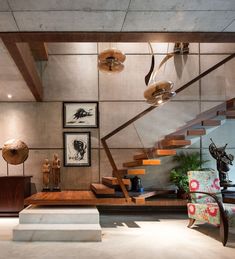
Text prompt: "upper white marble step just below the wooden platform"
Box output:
[[19, 205, 99, 224]]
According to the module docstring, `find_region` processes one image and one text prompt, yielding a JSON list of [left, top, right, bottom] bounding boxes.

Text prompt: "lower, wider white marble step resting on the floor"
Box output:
[[13, 224, 102, 243]]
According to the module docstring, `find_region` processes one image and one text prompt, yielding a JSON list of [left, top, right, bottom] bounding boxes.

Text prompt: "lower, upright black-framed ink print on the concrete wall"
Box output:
[[64, 132, 91, 167]]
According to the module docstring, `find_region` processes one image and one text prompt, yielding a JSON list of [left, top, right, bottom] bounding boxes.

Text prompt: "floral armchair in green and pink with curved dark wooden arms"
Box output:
[[187, 171, 235, 246]]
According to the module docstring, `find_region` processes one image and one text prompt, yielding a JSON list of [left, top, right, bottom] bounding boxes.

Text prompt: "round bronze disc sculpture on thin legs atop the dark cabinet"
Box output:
[[2, 139, 29, 175]]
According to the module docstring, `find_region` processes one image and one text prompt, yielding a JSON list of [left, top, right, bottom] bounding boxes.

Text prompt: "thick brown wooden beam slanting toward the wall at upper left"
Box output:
[[2, 38, 43, 101]]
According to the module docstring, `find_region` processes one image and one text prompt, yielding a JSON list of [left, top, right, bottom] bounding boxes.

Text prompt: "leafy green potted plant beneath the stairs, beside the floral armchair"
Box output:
[[170, 152, 207, 199]]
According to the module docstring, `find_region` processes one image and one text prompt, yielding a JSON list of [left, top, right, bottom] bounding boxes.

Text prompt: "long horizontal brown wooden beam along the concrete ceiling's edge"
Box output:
[[0, 32, 235, 43]]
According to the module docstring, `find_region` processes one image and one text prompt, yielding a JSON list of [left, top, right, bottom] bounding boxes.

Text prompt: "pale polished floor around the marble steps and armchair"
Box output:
[[0, 212, 235, 259]]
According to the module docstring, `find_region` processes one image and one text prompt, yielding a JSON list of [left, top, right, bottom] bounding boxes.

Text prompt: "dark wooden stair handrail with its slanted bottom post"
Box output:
[[101, 53, 235, 200]]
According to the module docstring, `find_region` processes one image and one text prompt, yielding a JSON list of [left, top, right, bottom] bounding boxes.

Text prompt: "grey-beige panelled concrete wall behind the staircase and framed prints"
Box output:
[[0, 43, 235, 191]]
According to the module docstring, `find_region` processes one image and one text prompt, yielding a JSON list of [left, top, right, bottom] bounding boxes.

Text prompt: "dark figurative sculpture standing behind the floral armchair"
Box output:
[[209, 139, 234, 187]]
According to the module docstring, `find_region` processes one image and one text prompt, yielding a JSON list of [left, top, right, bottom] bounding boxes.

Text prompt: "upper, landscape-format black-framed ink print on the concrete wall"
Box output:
[[63, 102, 99, 128]]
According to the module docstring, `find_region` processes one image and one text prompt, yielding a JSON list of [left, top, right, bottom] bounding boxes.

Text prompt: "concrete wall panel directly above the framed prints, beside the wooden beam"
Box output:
[[42, 55, 98, 101]]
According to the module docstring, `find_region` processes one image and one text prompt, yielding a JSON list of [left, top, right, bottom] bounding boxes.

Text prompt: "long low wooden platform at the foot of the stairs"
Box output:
[[25, 191, 187, 207]]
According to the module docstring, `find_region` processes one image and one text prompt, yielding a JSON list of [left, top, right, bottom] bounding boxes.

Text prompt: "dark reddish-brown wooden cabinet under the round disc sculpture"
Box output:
[[0, 176, 32, 216]]
